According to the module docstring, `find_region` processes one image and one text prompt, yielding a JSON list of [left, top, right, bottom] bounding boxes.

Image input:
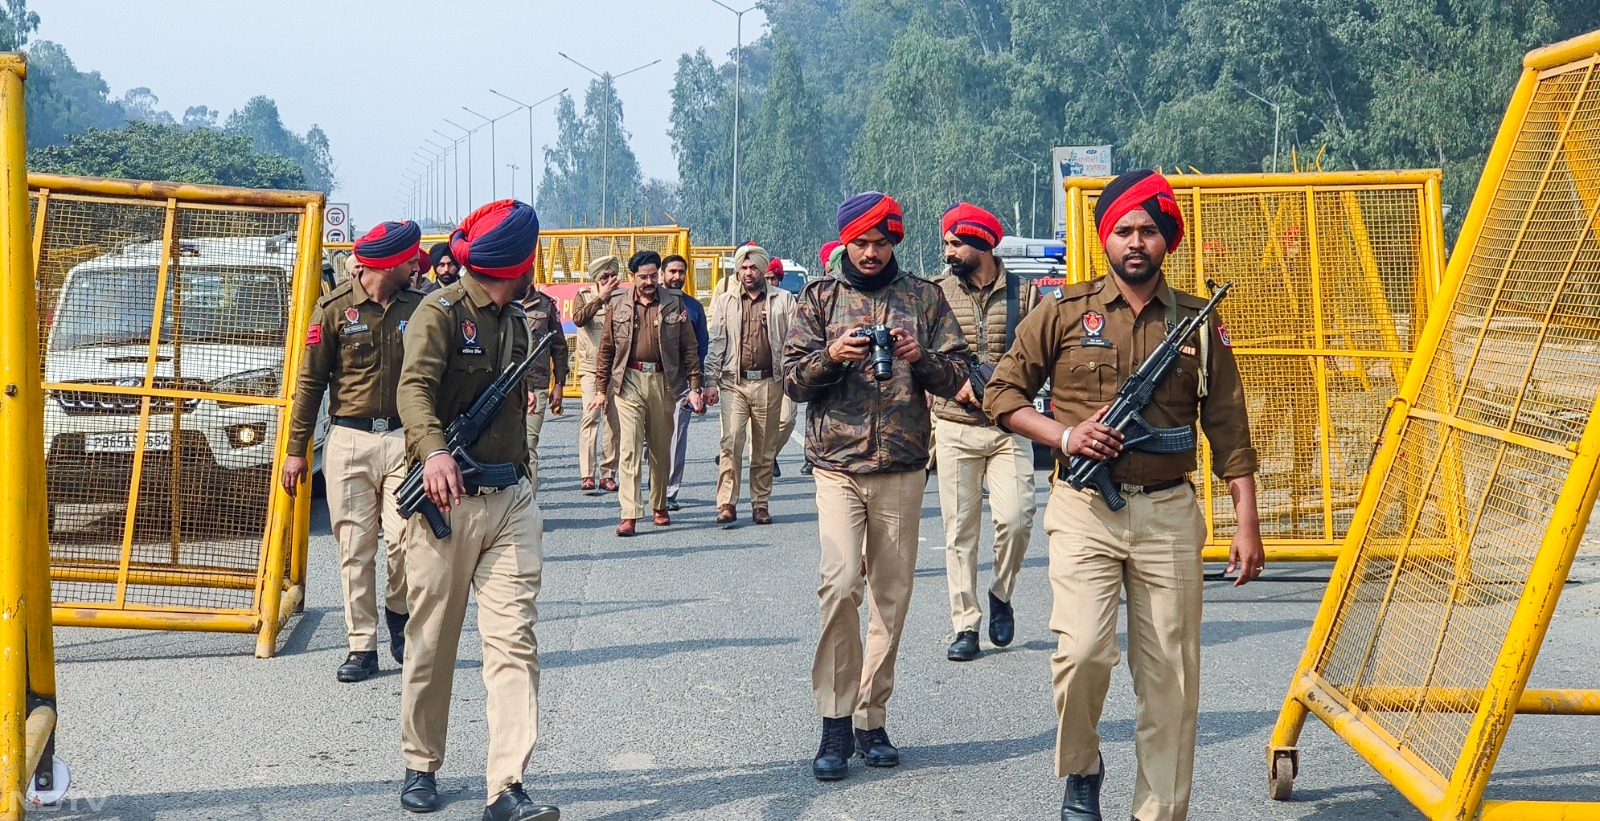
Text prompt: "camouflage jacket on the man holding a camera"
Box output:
[[784, 274, 966, 474]]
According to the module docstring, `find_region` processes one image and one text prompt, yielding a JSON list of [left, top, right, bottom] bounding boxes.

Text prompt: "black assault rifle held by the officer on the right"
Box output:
[[1067, 280, 1234, 511]]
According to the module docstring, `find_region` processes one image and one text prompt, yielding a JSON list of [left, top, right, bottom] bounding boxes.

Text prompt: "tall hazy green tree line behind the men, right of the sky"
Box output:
[[539, 0, 1600, 270]]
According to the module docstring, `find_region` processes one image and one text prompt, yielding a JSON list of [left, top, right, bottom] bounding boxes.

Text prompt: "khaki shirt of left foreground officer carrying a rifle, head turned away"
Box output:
[[397, 277, 528, 464]]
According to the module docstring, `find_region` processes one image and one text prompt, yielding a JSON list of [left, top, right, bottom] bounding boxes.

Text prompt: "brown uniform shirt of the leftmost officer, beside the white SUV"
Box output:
[[290, 277, 422, 456]]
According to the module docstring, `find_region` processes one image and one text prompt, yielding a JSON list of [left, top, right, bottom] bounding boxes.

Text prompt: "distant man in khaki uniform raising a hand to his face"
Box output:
[[573, 254, 622, 491]]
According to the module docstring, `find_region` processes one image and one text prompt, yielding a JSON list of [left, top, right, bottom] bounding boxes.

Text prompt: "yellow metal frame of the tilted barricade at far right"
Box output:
[[1266, 32, 1600, 821]]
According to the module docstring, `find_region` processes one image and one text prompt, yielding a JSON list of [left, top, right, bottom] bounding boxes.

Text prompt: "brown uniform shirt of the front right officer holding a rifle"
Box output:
[[984, 277, 1256, 485]]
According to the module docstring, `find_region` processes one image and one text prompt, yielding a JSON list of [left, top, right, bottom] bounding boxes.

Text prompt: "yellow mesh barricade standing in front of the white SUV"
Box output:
[[29, 174, 323, 656]]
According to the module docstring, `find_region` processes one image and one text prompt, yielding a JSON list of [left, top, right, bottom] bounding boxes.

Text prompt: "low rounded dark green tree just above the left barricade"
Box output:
[[27, 123, 306, 189]]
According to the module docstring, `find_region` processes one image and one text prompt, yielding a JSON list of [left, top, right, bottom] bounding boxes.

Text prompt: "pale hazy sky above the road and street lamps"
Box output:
[[29, 0, 765, 226]]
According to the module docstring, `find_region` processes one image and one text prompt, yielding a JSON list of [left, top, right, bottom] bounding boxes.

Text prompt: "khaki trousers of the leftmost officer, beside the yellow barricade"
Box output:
[[322, 424, 406, 653]]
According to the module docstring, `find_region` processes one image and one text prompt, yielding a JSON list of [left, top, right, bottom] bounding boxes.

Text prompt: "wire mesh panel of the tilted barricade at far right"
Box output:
[[1315, 57, 1600, 778]]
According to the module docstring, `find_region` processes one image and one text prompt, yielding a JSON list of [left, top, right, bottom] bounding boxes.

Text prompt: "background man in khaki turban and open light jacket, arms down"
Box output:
[[706, 248, 795, 525]]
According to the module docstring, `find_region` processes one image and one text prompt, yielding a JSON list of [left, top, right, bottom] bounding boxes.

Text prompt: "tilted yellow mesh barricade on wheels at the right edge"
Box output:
[[1267, 32, 1600, 819]]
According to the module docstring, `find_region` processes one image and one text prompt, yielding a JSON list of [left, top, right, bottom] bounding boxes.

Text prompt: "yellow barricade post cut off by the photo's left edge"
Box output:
[[0, 54, 66, 819]]
